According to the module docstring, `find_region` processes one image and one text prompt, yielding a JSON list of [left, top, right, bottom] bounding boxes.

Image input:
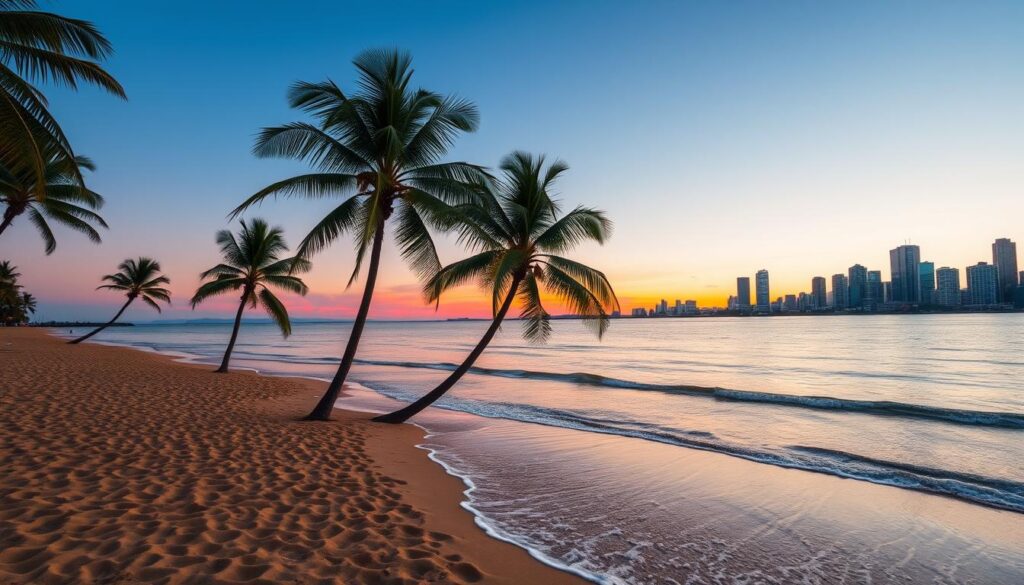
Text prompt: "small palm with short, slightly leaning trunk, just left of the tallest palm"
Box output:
[[191, 219, 310, 372]]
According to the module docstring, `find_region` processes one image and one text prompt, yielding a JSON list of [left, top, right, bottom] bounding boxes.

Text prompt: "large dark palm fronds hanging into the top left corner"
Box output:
[[0, 0, 125, 198]]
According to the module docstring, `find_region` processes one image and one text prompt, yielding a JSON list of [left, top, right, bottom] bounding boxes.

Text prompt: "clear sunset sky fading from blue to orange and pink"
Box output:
[[0, 0, 1024, 322]]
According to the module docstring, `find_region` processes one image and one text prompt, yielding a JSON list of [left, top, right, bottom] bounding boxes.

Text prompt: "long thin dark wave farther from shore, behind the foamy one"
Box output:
[[355, 360, 1024, 429]]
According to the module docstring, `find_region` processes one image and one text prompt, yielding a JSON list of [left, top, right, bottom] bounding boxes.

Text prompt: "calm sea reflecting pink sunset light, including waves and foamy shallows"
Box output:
[[64, 315, 1024, 583]]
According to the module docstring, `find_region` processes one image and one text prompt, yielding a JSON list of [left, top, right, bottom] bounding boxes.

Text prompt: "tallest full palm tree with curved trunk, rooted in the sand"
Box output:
[[232, 50, 485, 420]]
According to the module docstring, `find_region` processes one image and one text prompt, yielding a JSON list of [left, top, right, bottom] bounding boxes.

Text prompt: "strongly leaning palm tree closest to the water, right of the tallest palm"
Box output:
[[374, 152, 618, 423]]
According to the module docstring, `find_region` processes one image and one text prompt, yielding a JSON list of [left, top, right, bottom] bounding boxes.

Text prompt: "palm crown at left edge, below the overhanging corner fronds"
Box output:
[[0, 153, 108, 254]]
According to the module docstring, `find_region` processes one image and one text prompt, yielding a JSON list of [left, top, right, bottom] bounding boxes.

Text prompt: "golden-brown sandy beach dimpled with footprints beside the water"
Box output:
[[0, 329, 581, 584]]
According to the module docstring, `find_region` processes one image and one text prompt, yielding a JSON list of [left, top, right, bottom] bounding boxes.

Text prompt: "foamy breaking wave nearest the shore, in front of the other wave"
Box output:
[[358, 383, 1024, 513]]
